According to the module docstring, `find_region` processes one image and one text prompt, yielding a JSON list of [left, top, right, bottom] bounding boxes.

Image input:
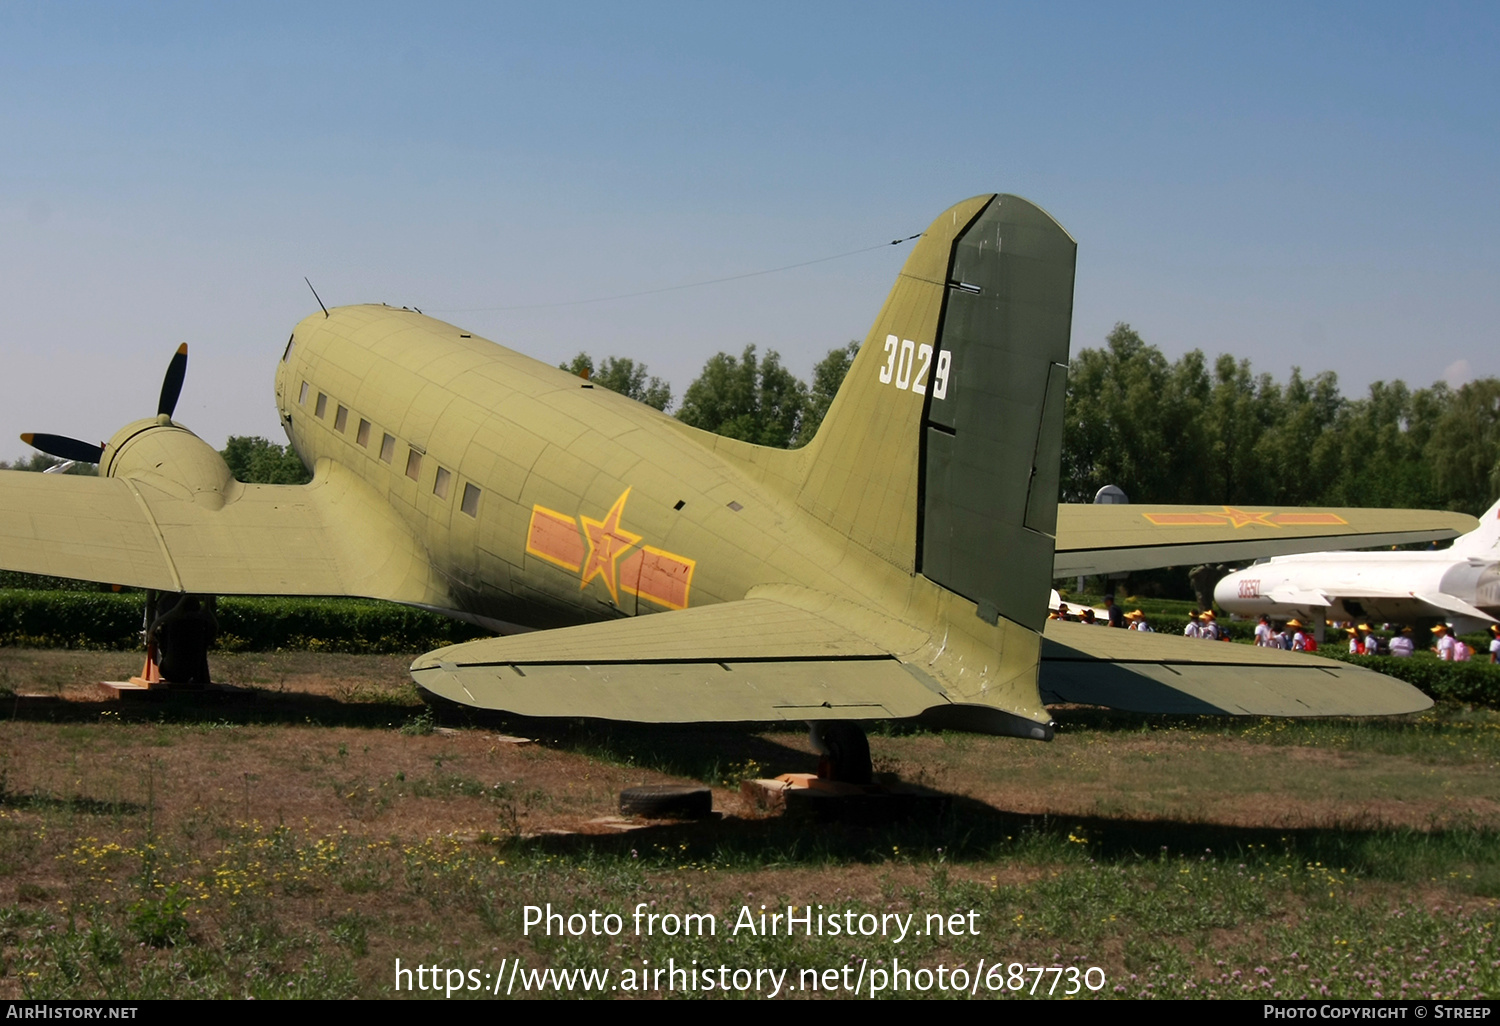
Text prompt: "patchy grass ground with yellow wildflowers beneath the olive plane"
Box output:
[[0, 654, 1500, 999]]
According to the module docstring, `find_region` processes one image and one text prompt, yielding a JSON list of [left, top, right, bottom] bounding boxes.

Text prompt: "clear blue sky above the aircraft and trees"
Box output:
[[0, 3, 1500, 458]]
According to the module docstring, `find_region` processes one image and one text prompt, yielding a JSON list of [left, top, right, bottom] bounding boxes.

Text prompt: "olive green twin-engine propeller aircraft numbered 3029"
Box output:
[[0, 195, 1473, 774]]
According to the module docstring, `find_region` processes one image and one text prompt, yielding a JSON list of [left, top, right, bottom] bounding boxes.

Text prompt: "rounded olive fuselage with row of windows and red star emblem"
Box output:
[[276, 306, 873, 627]]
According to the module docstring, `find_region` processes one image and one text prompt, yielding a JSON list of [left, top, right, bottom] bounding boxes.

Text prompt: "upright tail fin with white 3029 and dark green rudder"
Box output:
[[798, 195, 1077, 630]]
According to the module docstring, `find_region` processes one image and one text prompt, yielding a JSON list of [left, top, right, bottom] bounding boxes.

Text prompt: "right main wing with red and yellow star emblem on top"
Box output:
[[1053, 503, 1479, 578]]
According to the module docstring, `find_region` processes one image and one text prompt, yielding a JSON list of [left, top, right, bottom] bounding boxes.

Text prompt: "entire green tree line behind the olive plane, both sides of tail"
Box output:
[[0, 323, 1500, 515]]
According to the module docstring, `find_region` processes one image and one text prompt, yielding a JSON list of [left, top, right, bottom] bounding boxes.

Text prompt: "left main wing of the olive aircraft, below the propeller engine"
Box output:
[[0, 464, 443, 605]]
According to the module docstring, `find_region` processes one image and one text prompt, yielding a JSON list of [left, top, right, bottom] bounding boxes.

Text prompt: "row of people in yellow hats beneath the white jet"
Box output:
[[1047, 596, 1500, 663]]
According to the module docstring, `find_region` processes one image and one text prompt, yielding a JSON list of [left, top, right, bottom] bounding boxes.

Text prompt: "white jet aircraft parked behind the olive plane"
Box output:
[[1214, 503, 1500, 633]]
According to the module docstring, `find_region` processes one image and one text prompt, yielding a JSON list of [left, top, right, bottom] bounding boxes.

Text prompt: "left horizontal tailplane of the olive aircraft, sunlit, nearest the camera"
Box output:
[[411, 599, 966, 726]]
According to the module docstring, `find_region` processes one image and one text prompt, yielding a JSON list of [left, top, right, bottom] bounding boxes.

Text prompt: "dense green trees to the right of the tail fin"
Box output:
[[1062, 324, 1500, 515]]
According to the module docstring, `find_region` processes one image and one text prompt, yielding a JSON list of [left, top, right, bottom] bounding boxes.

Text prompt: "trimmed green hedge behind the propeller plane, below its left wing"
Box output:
[[0, 591, 486, 653]]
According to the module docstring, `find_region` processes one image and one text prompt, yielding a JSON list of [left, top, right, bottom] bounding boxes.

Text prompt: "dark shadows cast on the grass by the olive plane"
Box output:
[[0, 693, 1500, 872]]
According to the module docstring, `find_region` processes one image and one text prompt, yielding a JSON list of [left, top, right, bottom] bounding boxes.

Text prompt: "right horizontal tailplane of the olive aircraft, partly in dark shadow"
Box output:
[[1041, 621, 1433, 716]]
